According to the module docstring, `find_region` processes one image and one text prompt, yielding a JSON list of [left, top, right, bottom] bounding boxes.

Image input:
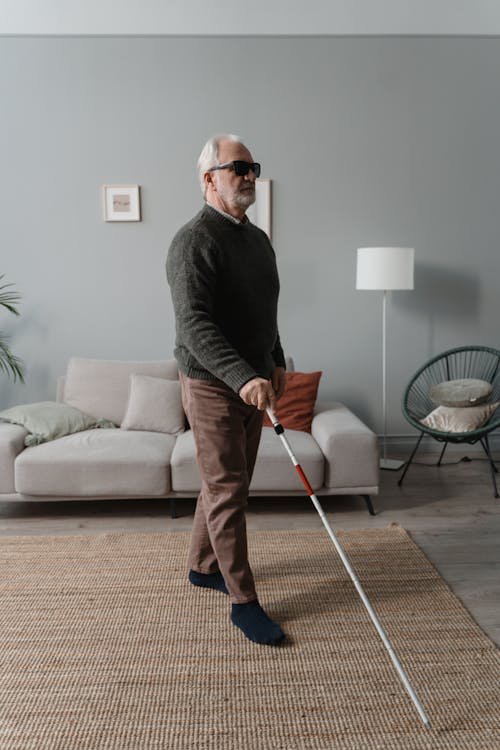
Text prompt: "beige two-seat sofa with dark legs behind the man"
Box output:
[[0, 358, 378, 513]]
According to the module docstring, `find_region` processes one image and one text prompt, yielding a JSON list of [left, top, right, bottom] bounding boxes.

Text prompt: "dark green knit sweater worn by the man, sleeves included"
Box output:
[[167, 204, 285, 392]]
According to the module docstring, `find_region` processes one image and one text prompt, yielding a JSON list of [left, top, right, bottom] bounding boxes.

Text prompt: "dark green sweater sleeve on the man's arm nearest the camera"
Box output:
[[167, 230, 257, 393]]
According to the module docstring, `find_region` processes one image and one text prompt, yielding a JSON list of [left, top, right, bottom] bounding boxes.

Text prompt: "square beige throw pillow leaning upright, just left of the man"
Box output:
[[121, 375, 186, 435]]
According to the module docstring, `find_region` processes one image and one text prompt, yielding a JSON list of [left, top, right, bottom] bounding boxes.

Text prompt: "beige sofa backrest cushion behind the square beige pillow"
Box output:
[[64, 357, 179, 425]]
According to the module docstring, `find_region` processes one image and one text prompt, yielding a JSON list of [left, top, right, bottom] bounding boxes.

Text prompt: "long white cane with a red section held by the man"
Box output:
[[266, 406, 430, 729]]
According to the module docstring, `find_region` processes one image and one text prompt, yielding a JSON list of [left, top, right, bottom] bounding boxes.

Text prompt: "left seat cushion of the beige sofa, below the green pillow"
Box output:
[[15, 430, 175, 497]]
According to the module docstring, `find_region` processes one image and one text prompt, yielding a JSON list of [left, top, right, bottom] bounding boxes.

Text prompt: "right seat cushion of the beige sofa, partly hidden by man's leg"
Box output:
[[171, 427, 324, 494]]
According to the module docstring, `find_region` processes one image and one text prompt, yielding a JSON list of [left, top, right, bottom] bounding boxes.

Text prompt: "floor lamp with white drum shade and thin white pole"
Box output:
[[356, 247, 415, 470]]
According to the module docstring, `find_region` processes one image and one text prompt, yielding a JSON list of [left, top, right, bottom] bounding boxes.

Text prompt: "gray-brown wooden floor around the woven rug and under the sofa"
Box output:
[[0, 452, 500, 645]]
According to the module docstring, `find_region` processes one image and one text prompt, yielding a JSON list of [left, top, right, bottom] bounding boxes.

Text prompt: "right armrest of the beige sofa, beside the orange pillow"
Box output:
[[311, 401, 379, 488]]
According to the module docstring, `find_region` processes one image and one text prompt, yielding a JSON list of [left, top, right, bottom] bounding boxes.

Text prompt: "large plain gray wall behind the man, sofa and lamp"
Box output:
[[0, 37, 500, 444]]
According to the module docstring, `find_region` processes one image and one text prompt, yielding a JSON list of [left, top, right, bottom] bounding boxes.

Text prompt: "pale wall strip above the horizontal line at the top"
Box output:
[[0, 0, 500, 36]]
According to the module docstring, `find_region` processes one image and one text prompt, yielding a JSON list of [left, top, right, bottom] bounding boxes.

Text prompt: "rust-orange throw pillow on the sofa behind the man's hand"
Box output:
[[264, 372, 322, 432]]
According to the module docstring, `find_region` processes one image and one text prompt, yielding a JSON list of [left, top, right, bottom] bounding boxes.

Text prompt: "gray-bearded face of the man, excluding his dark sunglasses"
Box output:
[[210, 141, 255, 215]]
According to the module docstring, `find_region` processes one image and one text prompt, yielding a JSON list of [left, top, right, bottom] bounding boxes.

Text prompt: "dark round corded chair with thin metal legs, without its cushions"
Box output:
[[398, 346, 500, 497]]
